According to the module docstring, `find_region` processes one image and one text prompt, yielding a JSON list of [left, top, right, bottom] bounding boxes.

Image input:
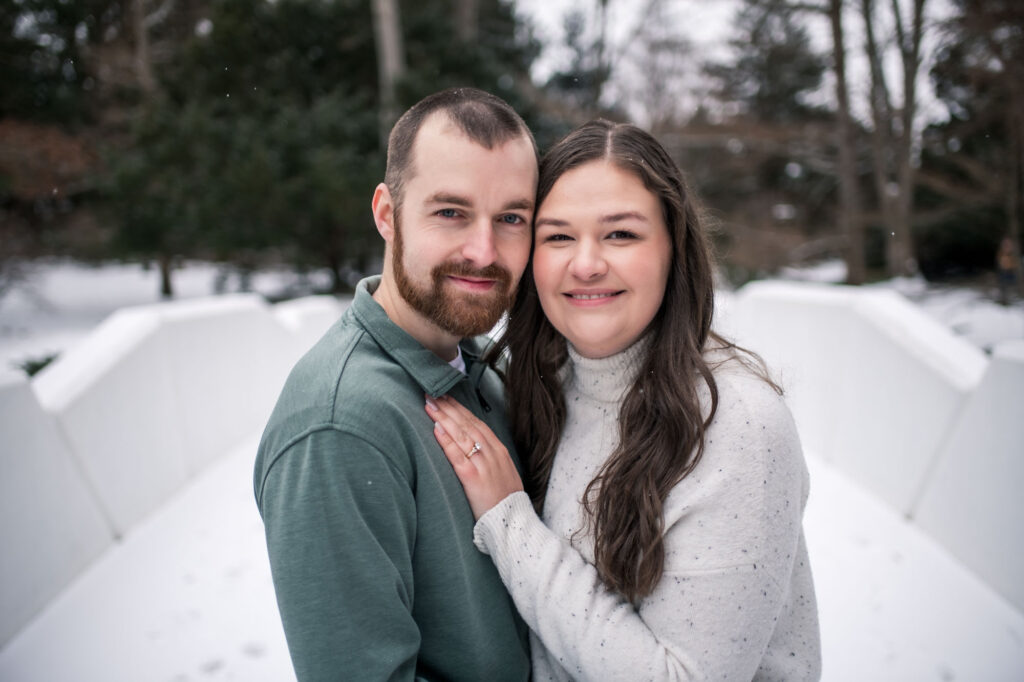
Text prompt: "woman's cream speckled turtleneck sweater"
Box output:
[[474, 344, 821, 682]]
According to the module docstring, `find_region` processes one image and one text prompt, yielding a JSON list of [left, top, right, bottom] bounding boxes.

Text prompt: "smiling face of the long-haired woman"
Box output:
[[534, 160, 672, 357]]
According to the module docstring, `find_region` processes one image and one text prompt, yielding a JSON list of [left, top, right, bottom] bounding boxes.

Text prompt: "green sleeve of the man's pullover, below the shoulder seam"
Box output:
[[258, 428, 420, 682]]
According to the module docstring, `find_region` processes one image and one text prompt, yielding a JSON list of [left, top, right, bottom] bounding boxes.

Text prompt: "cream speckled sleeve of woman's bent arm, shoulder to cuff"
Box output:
[[474, 376, 806, 681]]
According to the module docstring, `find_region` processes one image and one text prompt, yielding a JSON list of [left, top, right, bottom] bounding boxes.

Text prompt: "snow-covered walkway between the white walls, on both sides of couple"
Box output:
[[0, 435, 1024, 682]]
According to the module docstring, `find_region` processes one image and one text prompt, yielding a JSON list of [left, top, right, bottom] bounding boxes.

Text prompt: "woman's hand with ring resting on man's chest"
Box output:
[[426, 395, 523, 519]]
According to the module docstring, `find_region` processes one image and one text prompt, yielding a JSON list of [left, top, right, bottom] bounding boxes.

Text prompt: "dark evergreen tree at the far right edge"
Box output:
[[915, 0, 1024, 279]]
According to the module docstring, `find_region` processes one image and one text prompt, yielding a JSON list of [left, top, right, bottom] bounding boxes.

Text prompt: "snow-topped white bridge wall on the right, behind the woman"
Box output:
[[721, 282, 1024, 610]]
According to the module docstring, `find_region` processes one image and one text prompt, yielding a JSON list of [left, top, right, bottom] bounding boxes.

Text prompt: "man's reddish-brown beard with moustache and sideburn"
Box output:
[[391, 215, 515, 338]]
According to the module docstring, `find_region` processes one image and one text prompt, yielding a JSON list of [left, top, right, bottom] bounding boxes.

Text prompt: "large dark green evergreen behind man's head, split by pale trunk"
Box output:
[[103, 0, 537, 290]]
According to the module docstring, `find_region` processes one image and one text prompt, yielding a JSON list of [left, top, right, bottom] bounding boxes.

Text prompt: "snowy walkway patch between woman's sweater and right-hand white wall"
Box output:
[[804, 453, 1024, 682]]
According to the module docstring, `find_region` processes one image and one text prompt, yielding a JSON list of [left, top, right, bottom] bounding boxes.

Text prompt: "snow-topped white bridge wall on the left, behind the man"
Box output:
[[0, 295, 344, 645]]
